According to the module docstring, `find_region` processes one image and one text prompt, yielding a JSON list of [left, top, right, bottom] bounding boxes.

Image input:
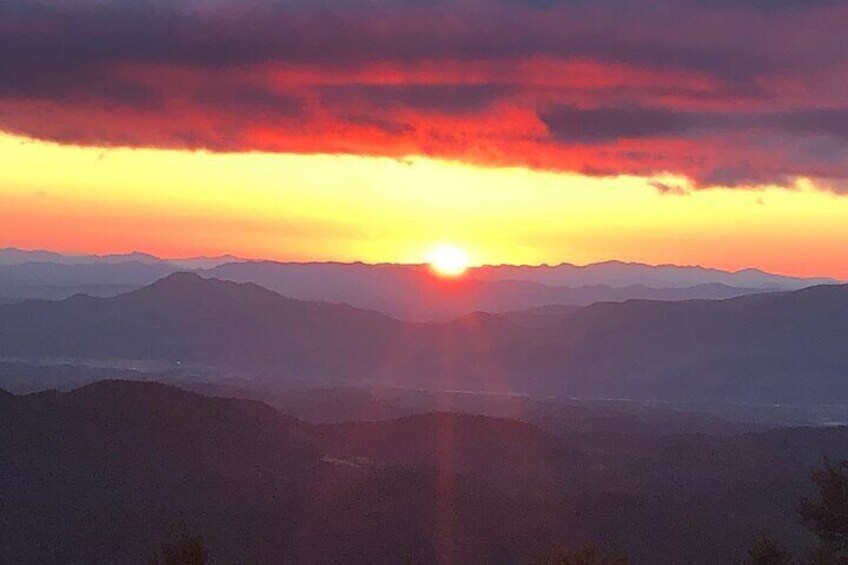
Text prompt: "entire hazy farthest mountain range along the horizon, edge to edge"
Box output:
[[0, 248, 838, 321]]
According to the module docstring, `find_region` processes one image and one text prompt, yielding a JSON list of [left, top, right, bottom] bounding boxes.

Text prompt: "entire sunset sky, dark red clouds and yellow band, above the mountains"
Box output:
[[0, 0, 848, 278]]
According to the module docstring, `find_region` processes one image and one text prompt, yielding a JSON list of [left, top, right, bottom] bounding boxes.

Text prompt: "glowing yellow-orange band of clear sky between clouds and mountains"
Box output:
[[0, 134, 848, 278]]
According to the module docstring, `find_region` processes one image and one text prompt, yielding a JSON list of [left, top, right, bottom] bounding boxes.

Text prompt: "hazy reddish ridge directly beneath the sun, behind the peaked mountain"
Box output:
[[201, 261, 784, 321]]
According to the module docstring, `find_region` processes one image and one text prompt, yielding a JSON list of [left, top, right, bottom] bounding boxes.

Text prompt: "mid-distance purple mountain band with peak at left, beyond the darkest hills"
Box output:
[[0, 274, 848, 402]]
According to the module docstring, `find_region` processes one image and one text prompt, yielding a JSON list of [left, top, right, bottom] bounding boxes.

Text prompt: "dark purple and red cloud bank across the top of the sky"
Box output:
[[0, 0, 848, 189]]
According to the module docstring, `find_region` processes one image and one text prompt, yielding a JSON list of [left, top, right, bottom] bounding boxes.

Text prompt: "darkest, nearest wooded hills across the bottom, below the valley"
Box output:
[[0, 381, 848, 565]]
